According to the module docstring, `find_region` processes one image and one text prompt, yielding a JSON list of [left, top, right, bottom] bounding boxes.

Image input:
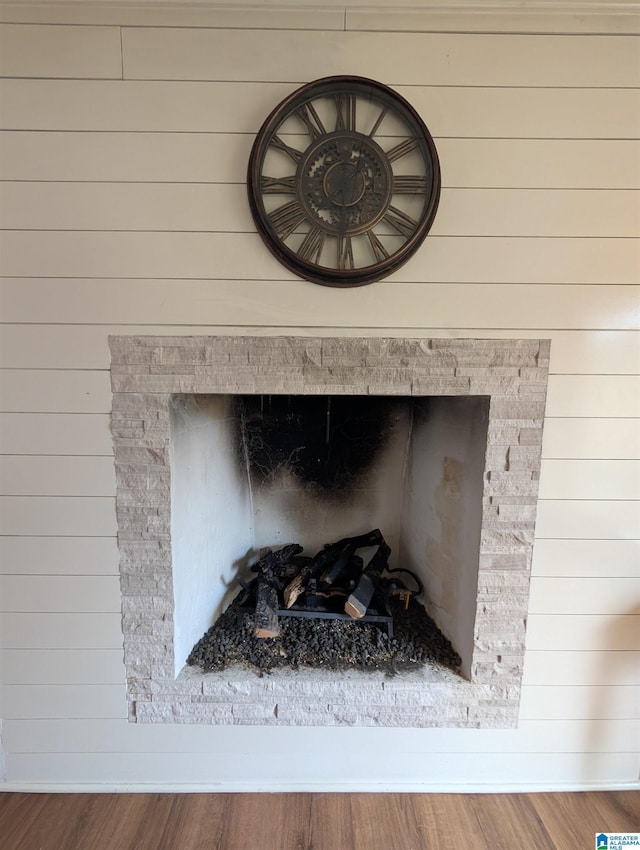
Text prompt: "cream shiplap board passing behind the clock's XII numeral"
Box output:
[[0, 80, 639, 139]]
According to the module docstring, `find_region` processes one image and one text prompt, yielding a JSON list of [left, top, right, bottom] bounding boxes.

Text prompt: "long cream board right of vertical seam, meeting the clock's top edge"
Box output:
[[122, 27, 640, 87]]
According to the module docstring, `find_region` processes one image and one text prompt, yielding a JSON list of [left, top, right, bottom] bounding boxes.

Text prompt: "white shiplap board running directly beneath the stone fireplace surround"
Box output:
[[3, 719, 637, 761]]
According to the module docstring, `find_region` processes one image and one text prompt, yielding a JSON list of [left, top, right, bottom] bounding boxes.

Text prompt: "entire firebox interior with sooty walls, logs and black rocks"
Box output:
[[171, 395, 488, 676]]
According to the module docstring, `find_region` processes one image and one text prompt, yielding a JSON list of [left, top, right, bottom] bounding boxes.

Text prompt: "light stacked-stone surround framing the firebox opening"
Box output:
[[110, 336, 549, 728]]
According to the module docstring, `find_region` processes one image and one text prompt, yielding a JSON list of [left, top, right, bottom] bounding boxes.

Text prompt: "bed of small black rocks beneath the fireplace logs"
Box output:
[[187, 598, 461, 675]]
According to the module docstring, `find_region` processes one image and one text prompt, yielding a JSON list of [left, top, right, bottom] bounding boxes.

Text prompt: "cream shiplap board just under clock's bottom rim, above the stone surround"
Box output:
[[0, 280, 640, 326]]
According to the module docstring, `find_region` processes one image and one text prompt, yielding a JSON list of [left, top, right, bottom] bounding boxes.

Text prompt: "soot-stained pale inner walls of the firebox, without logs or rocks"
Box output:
[[170, 395, 488, 678]]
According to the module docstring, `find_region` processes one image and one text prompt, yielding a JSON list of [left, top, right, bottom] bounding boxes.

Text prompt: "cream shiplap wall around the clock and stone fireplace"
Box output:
[[0, 4, 640, 790]]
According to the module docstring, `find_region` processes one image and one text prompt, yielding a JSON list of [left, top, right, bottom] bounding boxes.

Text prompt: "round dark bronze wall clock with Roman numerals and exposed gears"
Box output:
[[247, 77, 440, 286]]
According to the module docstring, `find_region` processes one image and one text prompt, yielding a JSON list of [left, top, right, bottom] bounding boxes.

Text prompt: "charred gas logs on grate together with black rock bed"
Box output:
[[187, 528, 460, 673]]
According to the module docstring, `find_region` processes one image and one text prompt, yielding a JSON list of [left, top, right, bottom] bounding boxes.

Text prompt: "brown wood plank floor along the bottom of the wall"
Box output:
[[0, 791, 640, 850]]
